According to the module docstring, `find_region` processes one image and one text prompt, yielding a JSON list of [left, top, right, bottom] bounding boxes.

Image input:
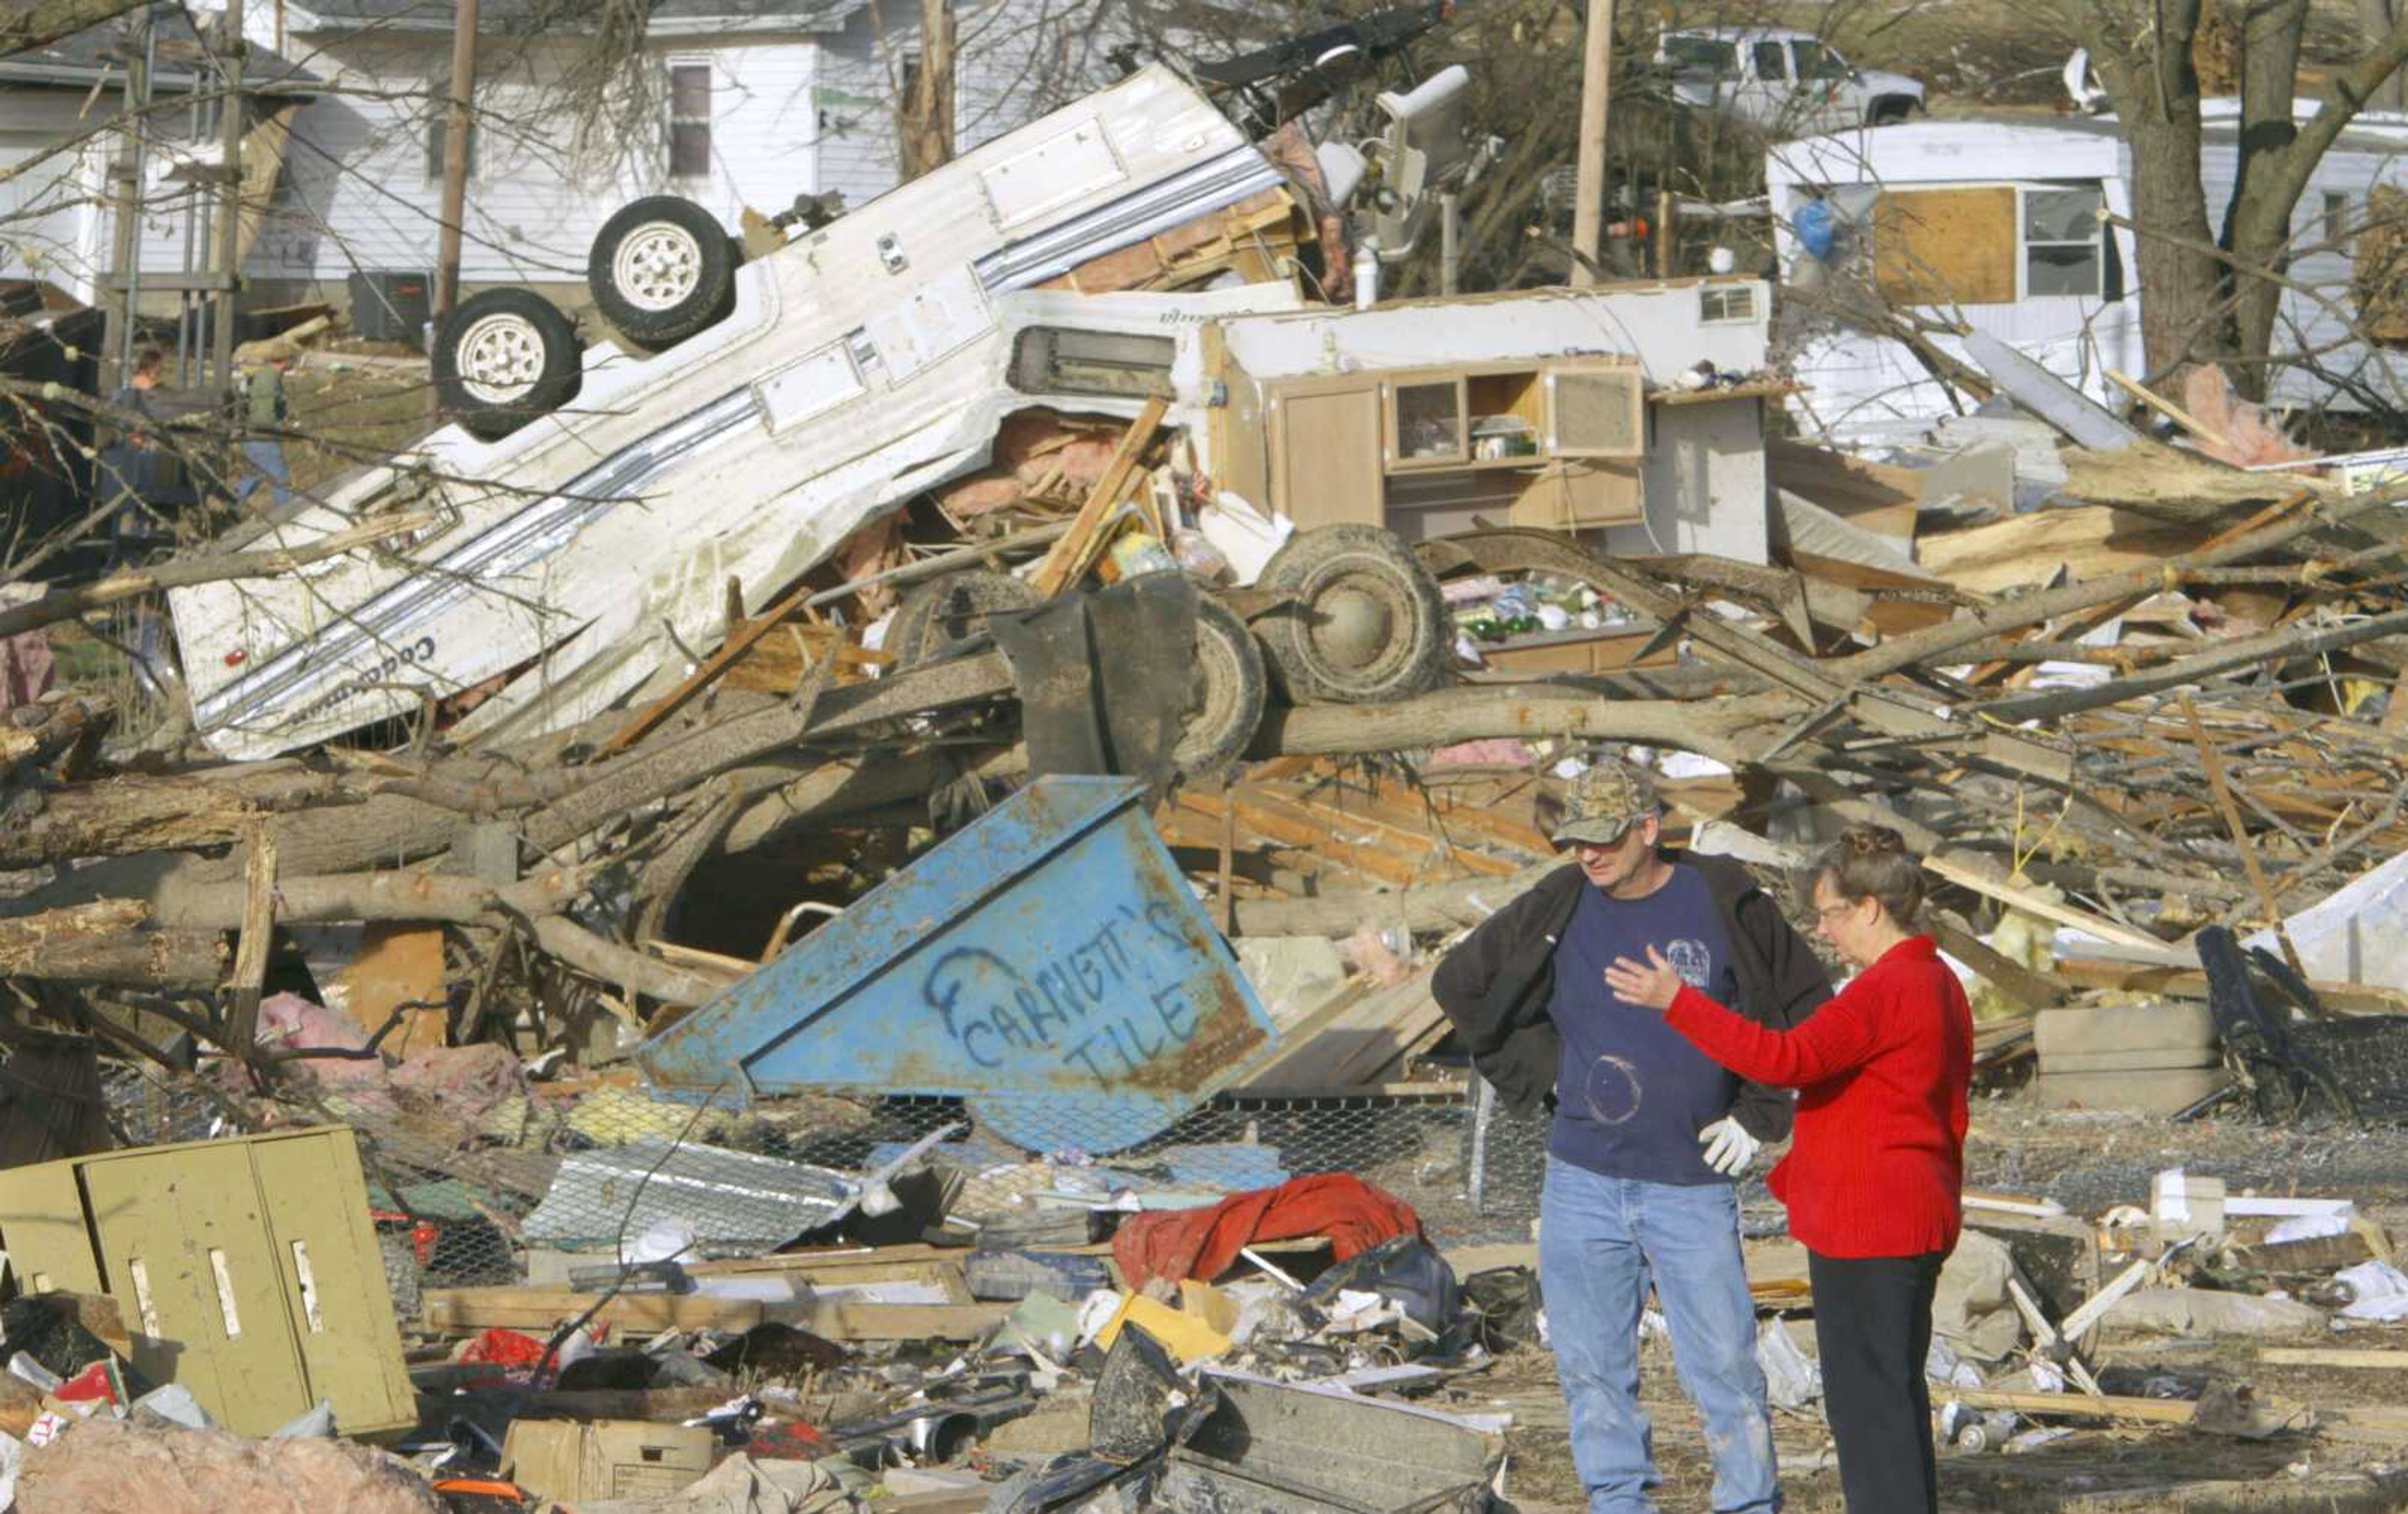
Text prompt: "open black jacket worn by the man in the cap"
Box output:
[[1430, 857, 1830, 1141]]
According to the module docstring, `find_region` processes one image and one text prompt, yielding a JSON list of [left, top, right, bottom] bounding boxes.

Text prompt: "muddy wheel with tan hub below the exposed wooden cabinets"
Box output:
[[1255, 525, 1450, 705]]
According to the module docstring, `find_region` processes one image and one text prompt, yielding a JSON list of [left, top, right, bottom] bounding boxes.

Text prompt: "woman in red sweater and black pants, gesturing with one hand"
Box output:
[[1606, 825, 1972, 1514]]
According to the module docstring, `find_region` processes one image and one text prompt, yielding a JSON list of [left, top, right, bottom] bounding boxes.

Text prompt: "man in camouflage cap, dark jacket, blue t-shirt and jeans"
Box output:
[[1430, 761, 1830, 1514]]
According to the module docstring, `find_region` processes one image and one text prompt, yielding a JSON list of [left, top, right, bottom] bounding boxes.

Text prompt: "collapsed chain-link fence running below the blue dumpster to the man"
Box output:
[[106, 1069, 1546, 1314]]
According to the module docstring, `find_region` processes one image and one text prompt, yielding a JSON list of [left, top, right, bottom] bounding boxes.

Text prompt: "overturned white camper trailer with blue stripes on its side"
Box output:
[[171, 67, 1296, 758]]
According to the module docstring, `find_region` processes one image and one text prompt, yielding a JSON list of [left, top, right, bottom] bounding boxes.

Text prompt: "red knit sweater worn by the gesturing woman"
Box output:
[[1666, 936, 1972, 1256]]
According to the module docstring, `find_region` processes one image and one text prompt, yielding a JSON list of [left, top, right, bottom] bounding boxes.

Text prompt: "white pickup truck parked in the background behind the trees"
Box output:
[[1654, 26, 1924, 137]]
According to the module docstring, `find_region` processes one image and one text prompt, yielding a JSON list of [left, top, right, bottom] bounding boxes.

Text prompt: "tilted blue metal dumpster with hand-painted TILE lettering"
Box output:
[[636, 778, 1274, 1153]]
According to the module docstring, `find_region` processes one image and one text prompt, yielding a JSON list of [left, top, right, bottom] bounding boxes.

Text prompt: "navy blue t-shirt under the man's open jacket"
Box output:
[[1546, 862, 1738, 1184]]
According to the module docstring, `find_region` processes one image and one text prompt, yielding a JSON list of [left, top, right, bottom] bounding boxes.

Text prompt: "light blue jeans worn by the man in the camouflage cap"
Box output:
[[1539, 1158, 1782, 1514]]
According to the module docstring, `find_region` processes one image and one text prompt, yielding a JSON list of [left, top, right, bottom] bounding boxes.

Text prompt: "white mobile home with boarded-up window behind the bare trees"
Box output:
[[1765, 101, 2408, 438]]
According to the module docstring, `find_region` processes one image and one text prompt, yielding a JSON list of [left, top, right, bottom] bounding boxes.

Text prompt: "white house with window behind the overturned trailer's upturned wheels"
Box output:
[[248, 0, 1131, 304]]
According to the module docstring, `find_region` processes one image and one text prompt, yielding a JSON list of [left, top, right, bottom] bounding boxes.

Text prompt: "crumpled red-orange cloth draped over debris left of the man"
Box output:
[[1112, 1172, 1421, 1288]]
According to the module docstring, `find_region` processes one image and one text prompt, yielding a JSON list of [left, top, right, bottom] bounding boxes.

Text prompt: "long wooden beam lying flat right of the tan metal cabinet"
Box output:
[[421, 1288, 1011, 1341]]
